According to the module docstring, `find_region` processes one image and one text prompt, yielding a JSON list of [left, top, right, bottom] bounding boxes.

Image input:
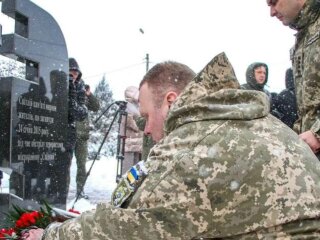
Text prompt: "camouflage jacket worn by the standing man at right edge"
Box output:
[[291, 0, 320, 137]]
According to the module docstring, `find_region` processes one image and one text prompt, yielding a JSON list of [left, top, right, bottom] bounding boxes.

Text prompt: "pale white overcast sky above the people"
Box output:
[[3, 0, 295, 100]]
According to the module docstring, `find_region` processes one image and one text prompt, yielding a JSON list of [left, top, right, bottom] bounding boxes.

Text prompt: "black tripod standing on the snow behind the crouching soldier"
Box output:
[[71, 101, 127, 209]]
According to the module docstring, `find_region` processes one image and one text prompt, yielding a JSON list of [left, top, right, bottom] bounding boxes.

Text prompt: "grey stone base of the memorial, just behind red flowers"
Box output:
[[0, 193, 40, 226]]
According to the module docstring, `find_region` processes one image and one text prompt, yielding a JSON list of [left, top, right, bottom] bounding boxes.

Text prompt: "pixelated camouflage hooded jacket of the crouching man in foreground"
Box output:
[[45, 54, 320, 240]]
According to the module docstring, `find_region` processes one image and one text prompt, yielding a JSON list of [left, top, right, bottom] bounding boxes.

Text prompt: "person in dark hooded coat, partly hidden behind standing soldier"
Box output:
[[271, 68, 298, 128]]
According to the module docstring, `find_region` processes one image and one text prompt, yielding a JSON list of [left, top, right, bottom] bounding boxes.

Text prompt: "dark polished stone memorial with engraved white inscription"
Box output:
[[0, 0, 69, 223]]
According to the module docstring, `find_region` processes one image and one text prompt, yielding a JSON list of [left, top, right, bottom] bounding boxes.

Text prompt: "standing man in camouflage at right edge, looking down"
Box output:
[[267, 0, 320, 156]]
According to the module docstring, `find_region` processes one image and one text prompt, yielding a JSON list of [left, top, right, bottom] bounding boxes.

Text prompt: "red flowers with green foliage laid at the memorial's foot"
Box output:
[[0, 202, 80, 240]]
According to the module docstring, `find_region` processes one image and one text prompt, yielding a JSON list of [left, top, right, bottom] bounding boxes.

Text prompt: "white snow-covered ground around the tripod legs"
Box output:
[[0, 156, 117, 212]]
